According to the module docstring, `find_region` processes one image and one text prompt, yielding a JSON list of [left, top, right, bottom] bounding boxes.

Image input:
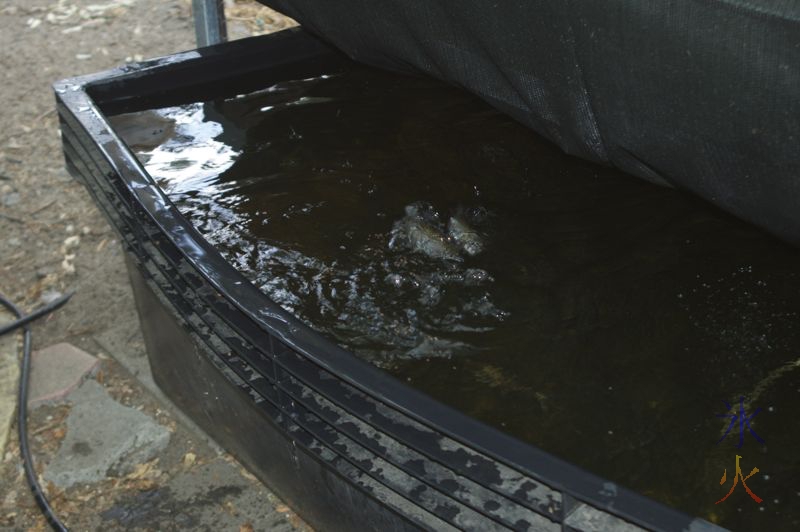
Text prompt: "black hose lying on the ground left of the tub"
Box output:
[[0, 294, 72, 532]]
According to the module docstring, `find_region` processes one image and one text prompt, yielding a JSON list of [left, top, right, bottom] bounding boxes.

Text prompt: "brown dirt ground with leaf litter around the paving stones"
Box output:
[[0, 0, 302, 530]]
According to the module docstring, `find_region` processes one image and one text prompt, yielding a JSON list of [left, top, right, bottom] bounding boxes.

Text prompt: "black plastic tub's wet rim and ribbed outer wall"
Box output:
[[55, 30, 714, 530]]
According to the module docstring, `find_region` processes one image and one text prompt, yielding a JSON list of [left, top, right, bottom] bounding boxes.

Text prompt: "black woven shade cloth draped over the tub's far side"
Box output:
[[260, 0, 800, 244]]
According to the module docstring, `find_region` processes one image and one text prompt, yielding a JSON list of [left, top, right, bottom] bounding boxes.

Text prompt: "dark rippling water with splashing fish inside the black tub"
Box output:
[[115, 64, 800, 530]]
